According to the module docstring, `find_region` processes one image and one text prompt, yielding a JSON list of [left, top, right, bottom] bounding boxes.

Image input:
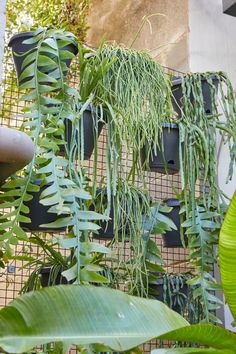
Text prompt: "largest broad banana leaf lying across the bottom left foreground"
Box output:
[[0, 285, 188, 353]]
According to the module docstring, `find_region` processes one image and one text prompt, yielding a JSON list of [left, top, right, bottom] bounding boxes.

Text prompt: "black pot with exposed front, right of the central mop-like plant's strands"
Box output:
[[141, 123, 180, 174]]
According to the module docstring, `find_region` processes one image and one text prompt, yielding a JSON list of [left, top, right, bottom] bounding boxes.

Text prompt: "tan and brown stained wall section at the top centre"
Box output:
[[87, 0, 189, 71]]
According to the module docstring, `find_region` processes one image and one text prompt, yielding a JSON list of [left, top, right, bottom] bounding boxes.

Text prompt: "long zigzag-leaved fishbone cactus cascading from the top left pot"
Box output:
[[0, 29, 111, 283]]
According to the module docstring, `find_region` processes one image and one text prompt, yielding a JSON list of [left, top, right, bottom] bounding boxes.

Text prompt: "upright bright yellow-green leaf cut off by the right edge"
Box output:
[[219, 192, 236, 321]]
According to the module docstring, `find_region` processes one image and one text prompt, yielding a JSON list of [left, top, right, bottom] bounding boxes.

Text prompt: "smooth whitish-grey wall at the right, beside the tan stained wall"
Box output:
[[189, 0, 236, 331]]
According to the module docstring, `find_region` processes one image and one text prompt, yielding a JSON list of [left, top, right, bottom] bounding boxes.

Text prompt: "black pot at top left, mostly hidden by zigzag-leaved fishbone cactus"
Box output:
[[8, 32, 78, 84]]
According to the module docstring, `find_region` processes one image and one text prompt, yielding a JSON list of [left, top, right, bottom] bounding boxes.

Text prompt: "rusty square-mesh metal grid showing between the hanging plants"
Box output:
[[0, 33, 188, 353]]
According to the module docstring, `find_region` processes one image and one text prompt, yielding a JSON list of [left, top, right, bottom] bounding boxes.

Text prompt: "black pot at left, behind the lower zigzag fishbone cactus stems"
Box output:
[[20, 181, 66, 232]]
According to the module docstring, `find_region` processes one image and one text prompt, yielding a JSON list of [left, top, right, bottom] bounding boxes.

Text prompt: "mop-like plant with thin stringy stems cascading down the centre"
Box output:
[[80, 44, 176, 296]]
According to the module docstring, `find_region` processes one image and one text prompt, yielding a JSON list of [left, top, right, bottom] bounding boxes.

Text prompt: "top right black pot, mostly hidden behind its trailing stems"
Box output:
[[172, 75, 218, 117]]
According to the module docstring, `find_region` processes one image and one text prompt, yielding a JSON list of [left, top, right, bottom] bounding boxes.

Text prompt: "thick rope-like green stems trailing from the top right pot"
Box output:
[[179, 72, 236, 213]]
